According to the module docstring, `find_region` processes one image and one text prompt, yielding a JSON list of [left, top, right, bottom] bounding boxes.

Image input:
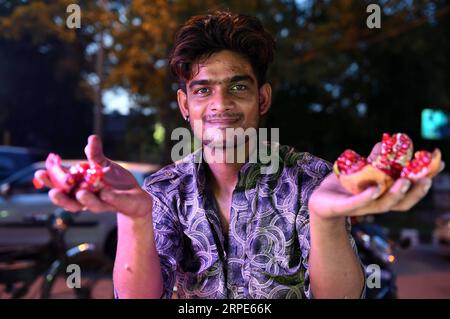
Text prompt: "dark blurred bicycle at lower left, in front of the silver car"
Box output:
[[0, 208, 113, 299]]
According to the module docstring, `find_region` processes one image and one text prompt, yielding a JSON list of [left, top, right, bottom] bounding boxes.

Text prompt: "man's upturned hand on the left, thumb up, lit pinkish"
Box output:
[[35, 135, 152, 218]]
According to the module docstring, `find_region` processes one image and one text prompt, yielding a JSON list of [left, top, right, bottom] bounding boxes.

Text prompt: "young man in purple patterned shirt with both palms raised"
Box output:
[[36, 12, 440, 298]]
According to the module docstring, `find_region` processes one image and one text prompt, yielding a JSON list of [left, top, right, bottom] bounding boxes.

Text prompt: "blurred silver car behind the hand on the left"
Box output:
[[0, 160, 159, 258]]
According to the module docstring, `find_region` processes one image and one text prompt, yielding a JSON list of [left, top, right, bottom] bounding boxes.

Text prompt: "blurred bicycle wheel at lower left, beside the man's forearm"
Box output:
[[41, 251, 113, 299]]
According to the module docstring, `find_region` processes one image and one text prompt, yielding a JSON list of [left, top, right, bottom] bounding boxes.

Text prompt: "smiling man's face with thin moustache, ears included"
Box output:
[[178, 51, 271, 147]]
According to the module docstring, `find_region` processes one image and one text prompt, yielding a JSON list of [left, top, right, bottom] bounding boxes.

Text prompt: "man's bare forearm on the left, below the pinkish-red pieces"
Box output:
[[114, 213, 163, 299]]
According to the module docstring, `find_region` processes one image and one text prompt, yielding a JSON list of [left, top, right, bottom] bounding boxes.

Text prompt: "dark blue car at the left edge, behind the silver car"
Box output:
[[0, 146, 47, 181]]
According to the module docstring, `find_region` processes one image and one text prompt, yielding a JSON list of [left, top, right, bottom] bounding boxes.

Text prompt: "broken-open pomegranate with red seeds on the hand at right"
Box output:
[[334, 133, 441, 194]]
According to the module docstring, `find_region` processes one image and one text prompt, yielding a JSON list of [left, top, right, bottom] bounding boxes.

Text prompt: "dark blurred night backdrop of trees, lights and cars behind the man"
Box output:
[[0, 0, 450, 298]]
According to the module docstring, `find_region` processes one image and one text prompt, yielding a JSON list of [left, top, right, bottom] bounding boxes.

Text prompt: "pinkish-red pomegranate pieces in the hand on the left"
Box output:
[[33, 153, 104, 197]]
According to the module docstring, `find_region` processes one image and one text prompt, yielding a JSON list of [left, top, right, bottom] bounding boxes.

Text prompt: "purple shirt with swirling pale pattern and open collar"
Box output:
[[143, 146, 362, 299]]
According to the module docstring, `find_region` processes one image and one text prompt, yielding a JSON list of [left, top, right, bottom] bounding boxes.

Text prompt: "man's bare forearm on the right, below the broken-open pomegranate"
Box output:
[[309, 213, 365, 298]]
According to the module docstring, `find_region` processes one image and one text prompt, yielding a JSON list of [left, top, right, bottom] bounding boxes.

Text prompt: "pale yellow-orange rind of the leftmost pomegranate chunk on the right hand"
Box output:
[[334, 163, 394, 194]]
